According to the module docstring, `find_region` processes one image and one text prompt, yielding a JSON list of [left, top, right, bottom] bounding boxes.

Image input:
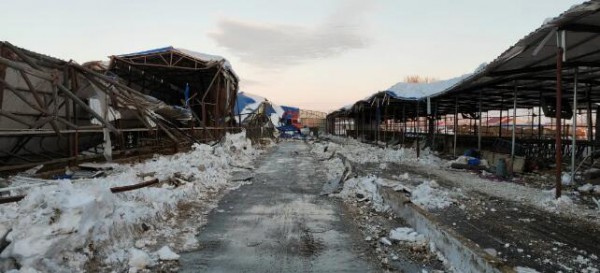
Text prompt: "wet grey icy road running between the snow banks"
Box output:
[[180, 142, 380, 272]]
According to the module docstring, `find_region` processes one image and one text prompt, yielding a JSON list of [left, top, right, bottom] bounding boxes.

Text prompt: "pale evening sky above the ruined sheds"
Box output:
[[0, 0, 583, 112]]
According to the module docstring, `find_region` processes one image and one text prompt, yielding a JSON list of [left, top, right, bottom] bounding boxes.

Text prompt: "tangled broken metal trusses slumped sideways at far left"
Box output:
[[0, 42, 244, 171]]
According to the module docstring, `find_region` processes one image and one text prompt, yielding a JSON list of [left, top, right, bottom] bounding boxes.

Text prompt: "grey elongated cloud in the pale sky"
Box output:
[[208, 0, 373, 69]]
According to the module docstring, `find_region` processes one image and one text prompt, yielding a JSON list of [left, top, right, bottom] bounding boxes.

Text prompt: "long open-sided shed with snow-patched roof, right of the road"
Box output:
[[328, 1, 600, 197]]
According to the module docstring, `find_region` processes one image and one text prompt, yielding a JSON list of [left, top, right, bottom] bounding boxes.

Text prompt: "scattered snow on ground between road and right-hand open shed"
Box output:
[[311, 136, 600, 272]]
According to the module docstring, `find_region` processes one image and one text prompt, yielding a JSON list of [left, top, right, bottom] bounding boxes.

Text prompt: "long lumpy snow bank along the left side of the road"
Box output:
[[0, 133, 260, 273]]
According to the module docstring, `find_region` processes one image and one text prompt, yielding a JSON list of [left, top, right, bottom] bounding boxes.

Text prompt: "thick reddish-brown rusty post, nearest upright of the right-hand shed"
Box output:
[[555, 46, 564, 198]]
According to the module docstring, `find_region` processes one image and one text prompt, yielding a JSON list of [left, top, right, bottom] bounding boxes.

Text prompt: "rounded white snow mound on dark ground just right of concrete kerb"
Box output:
[[410, 180, 455, 210]]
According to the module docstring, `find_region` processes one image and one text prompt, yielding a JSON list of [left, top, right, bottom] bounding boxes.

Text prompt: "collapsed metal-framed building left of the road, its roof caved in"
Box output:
[[0, 42, 239, 172]]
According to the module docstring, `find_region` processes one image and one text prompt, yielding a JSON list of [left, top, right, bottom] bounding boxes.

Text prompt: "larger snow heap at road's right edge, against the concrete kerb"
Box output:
[[332, 176, 388, 212]]
